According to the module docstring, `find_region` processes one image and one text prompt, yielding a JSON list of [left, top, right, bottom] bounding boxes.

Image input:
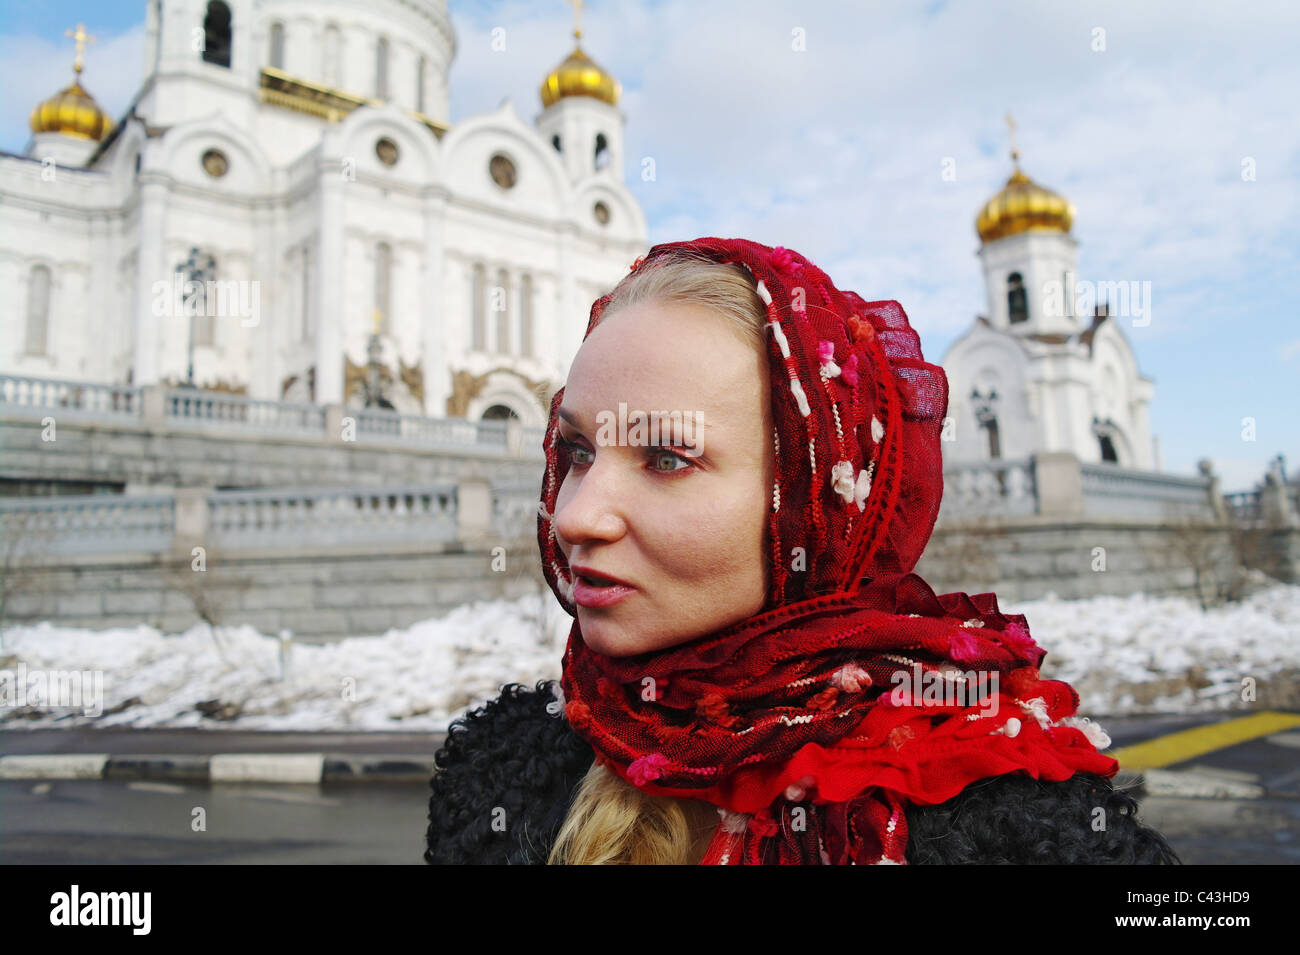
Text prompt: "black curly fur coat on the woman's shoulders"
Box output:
[[424, 681, 1179, 864]]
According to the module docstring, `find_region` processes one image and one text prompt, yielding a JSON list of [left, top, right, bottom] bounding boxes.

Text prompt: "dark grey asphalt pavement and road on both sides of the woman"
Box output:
[[0, 716, 1300, 865]]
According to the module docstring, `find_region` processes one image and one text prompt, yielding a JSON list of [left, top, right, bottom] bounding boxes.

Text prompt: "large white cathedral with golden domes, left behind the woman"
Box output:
[[0, 0, 647, 425]]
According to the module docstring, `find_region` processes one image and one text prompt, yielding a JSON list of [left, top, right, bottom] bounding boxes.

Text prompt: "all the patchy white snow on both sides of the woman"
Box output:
[[0, 574, 1300, 730]]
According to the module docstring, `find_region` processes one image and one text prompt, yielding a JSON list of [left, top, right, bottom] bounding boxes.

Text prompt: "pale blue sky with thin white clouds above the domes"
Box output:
[[0, 0, 1300, 490]]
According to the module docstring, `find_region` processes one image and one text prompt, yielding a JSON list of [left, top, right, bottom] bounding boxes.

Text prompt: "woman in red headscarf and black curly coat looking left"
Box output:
[[425, 238, 1178, 864]]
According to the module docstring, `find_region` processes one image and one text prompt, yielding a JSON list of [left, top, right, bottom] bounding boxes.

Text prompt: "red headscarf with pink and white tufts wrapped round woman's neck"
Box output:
[[538, 238, 1119, 864]]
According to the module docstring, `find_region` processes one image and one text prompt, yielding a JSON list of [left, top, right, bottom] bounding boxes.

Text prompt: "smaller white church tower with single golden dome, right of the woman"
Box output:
[[941, 147, 1162, 470]]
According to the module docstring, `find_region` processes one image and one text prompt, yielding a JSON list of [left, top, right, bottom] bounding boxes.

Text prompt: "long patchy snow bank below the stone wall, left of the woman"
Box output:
[[0, 591, 572, 732]]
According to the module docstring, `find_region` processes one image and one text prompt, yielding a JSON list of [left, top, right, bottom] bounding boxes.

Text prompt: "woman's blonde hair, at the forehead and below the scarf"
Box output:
[[547, 251, 767, 865]]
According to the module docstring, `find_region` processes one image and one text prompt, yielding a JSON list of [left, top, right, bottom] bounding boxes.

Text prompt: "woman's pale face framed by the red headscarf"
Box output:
[[554, 301, 772, 656]]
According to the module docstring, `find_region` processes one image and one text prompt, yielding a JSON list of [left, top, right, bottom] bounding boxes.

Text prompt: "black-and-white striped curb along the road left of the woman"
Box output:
[[0, 752, 434, 785]]
